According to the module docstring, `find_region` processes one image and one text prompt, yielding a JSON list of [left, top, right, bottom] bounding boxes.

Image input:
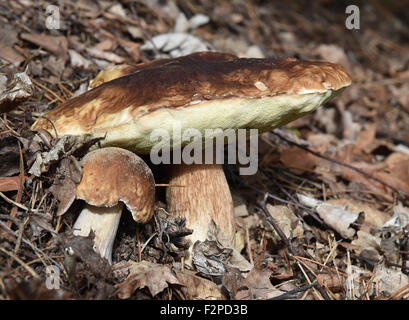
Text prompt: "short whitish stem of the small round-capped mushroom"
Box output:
[[73, 202, 123, 265]]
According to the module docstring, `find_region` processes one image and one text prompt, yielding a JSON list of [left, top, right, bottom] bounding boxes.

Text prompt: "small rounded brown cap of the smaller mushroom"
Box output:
[[77, 147, 155, 223]]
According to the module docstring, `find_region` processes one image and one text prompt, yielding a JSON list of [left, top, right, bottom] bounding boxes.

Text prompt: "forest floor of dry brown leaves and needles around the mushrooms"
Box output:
[[0, 0, 409, 300]]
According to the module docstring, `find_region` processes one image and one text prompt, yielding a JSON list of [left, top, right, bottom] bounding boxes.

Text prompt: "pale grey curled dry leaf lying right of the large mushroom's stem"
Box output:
[[297, 194, 364, 239]]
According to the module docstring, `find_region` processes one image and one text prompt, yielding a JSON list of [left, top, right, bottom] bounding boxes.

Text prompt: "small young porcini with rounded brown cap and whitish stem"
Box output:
[[73, 147, 155, 264]]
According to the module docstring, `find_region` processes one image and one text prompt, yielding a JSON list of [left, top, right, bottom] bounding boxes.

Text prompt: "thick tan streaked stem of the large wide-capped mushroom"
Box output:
[[166, 164, 235, 264]]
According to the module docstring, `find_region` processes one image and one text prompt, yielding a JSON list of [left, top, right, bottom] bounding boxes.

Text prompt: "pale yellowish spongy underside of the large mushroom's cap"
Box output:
[[57, 90, 334, 154]]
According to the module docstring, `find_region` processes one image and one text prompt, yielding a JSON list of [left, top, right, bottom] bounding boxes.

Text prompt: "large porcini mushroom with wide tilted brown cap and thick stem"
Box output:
[[32, 52, 351, 262]]
